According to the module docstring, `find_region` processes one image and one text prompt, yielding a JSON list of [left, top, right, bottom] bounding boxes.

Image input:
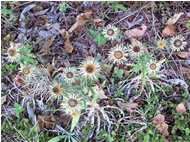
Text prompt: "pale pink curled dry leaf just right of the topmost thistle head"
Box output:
[[125, 24, 147, 38]]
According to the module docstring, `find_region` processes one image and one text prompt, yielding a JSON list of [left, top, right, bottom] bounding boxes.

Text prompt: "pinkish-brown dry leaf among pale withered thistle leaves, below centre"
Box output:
[[117, 101, 138, 113]]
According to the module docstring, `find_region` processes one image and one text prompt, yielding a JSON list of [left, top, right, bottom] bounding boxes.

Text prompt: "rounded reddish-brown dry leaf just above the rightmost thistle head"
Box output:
[[162, 25, 176, 37]]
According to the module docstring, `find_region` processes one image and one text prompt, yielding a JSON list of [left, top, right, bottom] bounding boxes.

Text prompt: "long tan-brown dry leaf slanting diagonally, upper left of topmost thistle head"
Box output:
[[68, 10, 92, 33]]
